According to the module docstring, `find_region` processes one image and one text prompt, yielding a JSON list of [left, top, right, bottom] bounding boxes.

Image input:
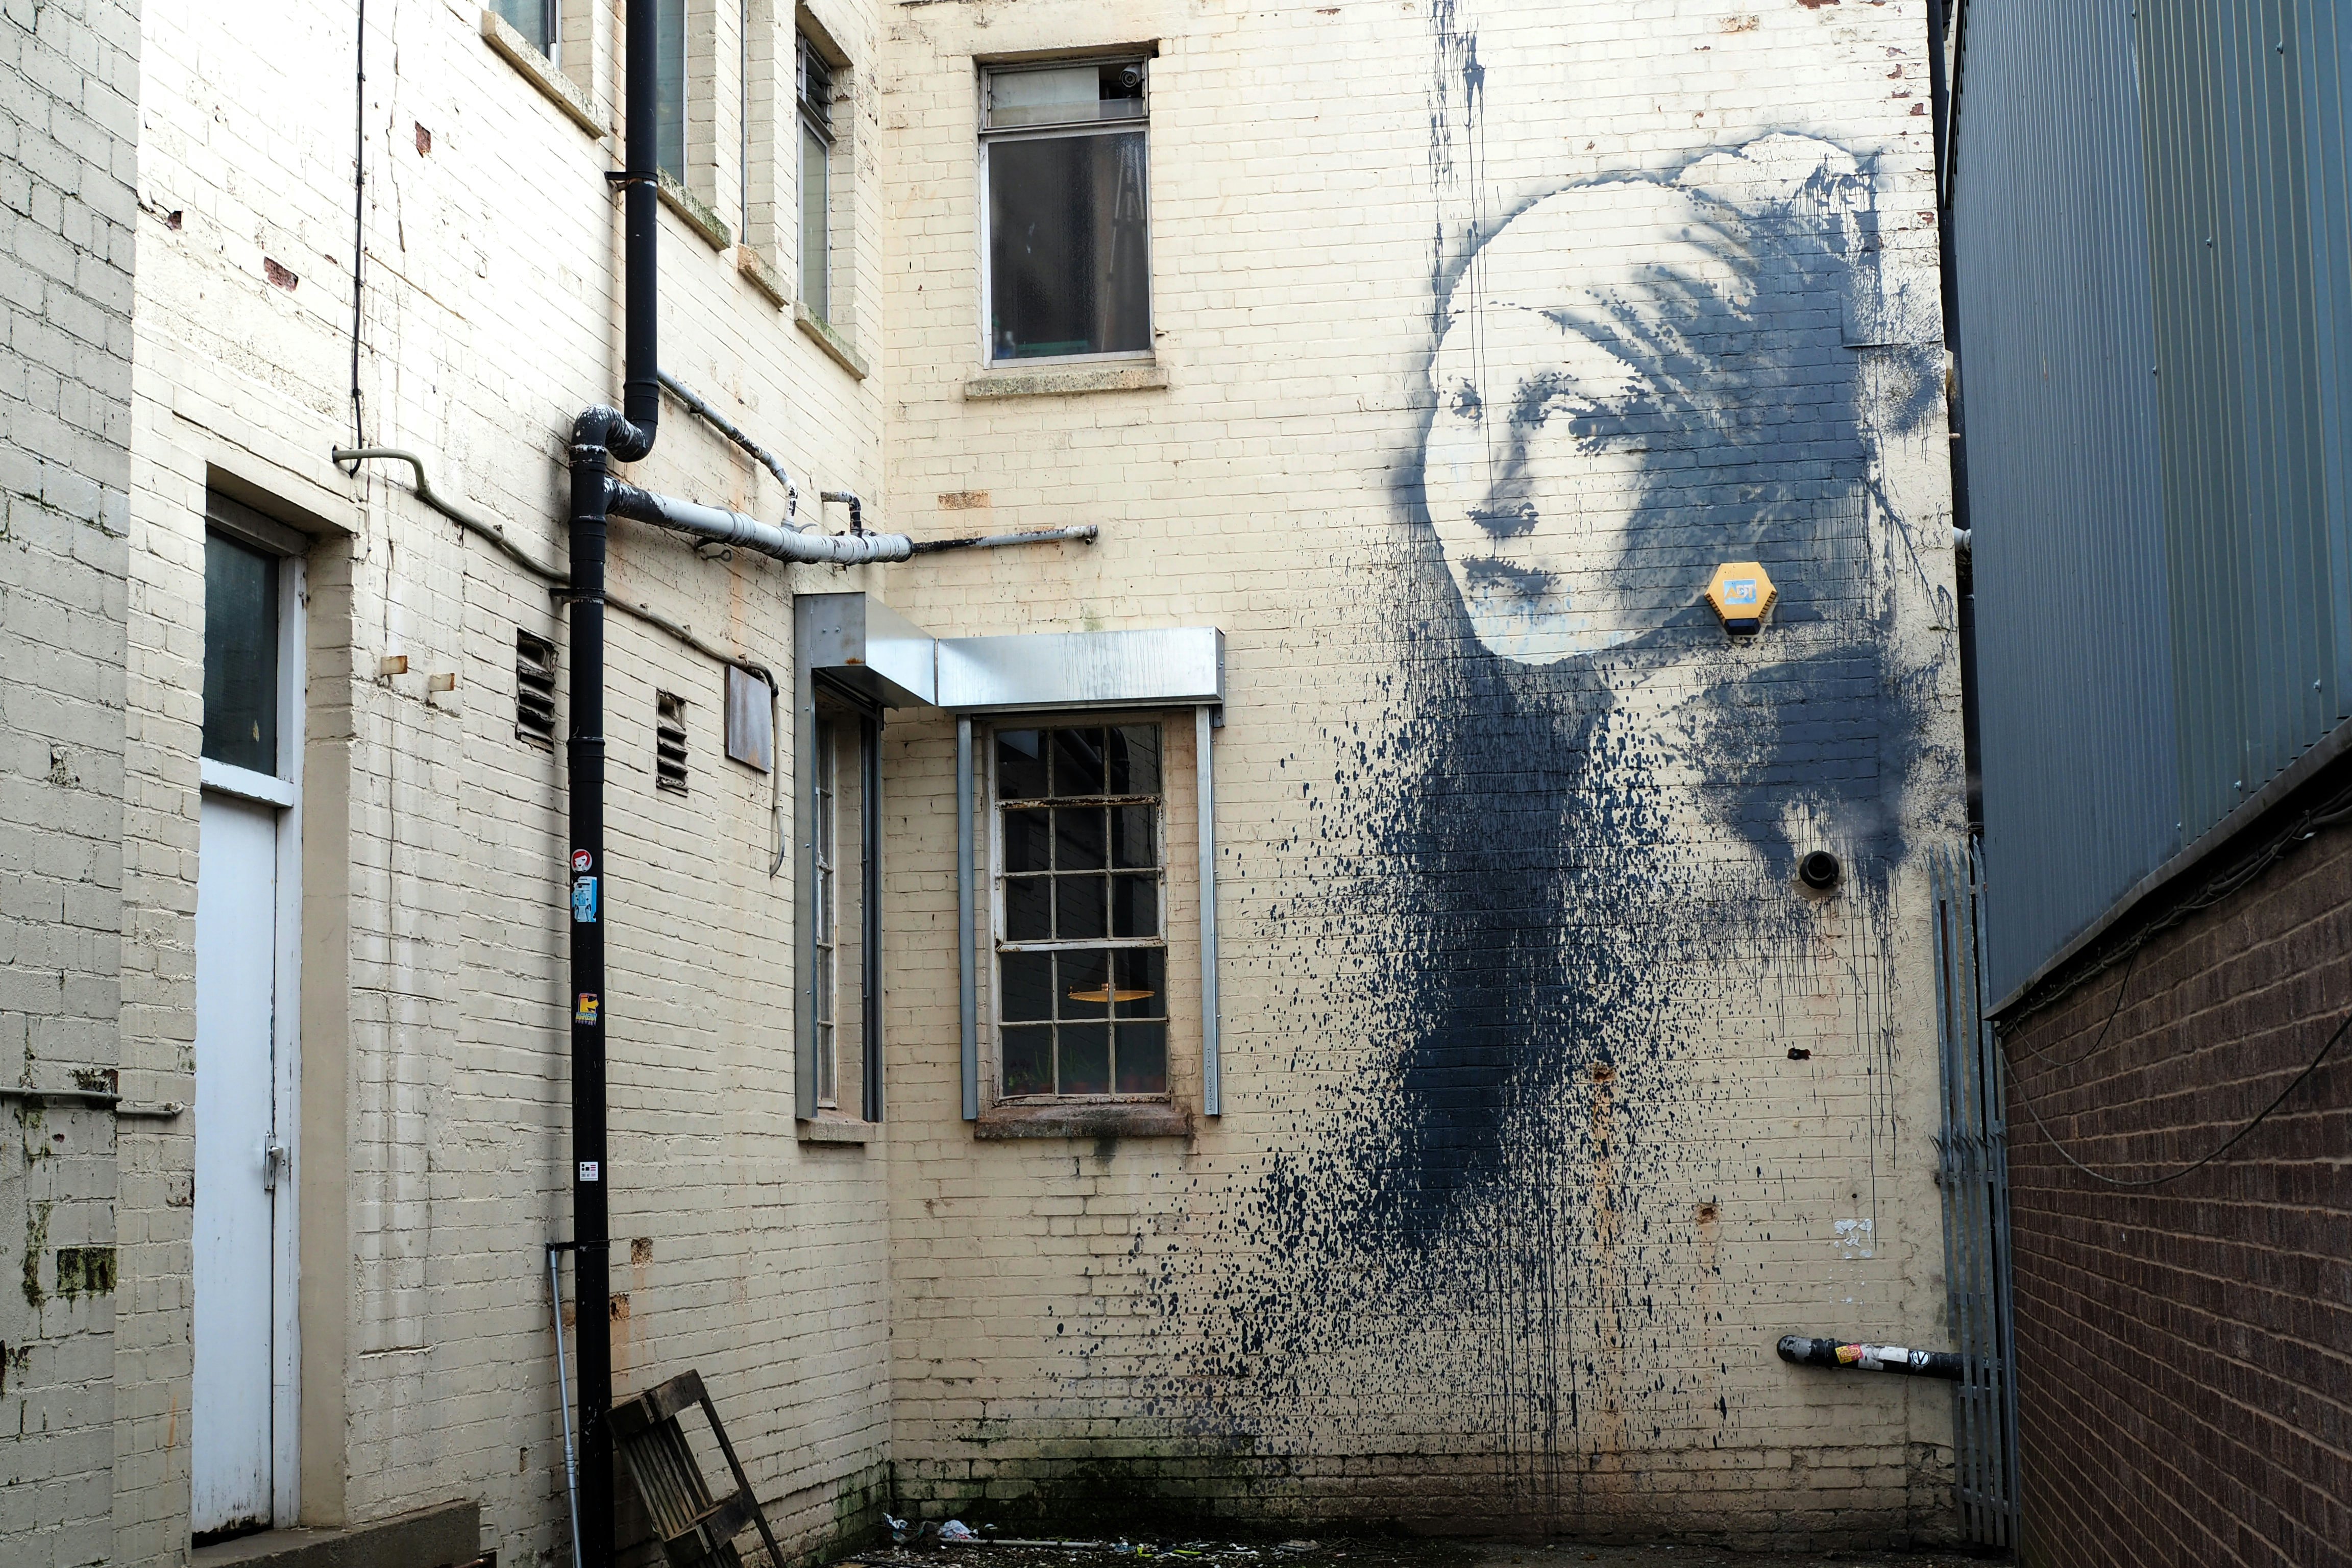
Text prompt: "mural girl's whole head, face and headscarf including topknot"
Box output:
[[1423, 136, 1870, 665]]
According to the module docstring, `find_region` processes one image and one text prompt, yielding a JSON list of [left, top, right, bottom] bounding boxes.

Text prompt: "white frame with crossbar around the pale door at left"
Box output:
[[198, 492, 310, 1528]]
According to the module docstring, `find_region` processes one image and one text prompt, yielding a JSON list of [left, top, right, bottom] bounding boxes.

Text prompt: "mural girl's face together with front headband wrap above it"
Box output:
[[1420, 181, 1752, 665]]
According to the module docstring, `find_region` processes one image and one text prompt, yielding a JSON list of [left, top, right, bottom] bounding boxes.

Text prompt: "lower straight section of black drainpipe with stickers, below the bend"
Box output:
[[565, 442, 611, 1568]]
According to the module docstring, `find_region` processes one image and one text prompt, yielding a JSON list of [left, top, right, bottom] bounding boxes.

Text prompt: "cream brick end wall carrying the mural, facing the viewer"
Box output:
[[885, 3, 1959, 1540]]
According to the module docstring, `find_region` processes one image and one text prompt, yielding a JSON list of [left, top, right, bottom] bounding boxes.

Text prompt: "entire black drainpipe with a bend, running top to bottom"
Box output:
[[567, 0, 661, 1568]]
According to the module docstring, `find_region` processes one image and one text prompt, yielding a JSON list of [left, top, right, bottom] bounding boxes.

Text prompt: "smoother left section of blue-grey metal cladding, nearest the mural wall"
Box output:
[[1952, 0, 2180, 994]]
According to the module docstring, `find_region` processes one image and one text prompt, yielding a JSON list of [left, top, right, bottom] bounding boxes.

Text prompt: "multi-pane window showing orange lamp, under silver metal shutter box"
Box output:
[[990, 724, 1169, 1100]]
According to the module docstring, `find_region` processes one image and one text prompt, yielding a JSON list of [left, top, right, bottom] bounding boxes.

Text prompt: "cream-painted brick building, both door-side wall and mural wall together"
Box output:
[[12, 0, 1959, 1563]]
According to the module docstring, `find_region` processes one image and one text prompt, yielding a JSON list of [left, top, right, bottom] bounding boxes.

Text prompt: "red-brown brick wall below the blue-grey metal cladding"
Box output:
[[2004, 827, 2352, 1568]]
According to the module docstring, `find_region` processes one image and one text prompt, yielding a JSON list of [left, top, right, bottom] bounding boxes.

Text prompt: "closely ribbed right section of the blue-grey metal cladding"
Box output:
[[2138, 0, 2352, 837]]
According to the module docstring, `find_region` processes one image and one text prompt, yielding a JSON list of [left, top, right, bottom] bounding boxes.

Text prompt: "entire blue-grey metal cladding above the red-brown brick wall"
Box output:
[[1952, 0, 2352, 994]]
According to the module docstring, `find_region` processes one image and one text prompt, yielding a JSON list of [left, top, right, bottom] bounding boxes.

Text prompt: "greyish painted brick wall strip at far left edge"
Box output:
[[0, 0, 139, 1568]]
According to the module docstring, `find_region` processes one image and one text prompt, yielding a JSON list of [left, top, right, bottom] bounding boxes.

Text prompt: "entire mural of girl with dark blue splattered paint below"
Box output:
[[1185, 134, 1945, 1516]]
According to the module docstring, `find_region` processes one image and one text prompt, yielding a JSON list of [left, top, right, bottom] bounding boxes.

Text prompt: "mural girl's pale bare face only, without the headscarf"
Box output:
[[1423, 301, 1656, 665]]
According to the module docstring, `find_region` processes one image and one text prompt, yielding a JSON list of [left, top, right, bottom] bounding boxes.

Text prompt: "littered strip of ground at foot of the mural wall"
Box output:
[[835, 1535, 2006, 1568]]
